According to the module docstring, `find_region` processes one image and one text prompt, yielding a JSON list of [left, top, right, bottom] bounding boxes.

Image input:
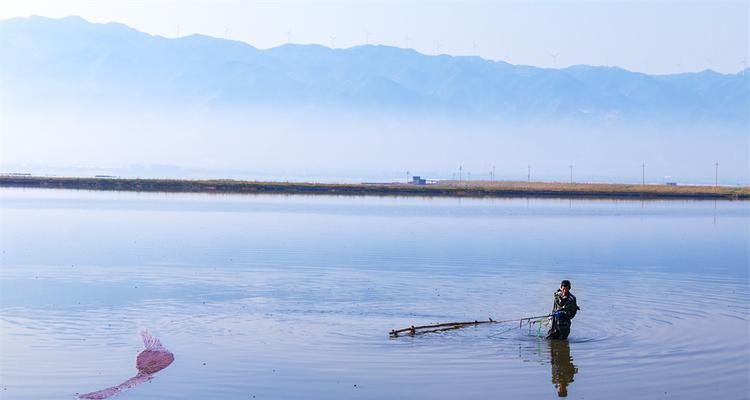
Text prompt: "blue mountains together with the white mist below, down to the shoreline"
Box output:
[[0, 17, 748, 185]]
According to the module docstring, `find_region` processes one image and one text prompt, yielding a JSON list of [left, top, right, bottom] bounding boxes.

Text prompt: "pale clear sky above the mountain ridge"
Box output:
[[0, 0, 750, 74]]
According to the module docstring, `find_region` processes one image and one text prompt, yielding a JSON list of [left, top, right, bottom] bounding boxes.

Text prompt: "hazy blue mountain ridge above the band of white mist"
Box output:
[[0, 17, 750, 124]]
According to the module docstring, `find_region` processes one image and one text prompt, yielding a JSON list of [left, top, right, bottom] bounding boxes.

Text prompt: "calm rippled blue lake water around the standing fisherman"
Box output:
[[0, 189, 750, 399]]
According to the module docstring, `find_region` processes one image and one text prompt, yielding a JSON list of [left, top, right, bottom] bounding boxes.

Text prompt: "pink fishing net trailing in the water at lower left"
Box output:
[[78, 330, 174, 399]]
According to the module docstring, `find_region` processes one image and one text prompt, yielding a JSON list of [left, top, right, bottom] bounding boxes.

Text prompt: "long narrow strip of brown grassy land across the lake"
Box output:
[[0, 175, 750, 200]]
